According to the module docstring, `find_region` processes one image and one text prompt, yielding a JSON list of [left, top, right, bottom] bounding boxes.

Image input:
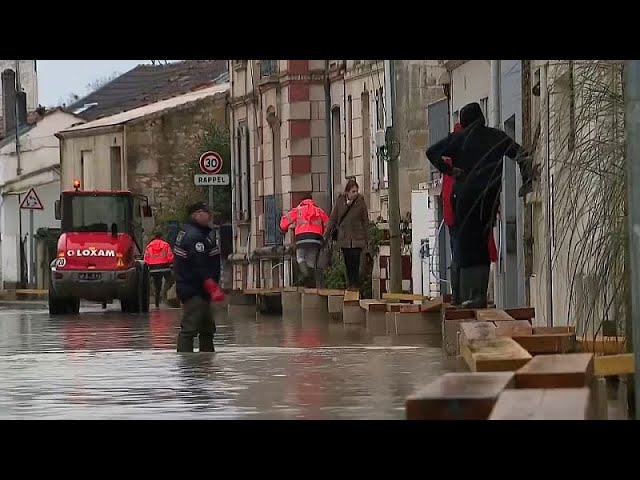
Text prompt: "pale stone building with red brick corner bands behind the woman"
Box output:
[[229, 60, 444, 293]]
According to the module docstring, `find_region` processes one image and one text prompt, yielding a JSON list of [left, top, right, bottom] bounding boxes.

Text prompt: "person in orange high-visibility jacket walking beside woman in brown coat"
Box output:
[[280, 194, 329, 285]]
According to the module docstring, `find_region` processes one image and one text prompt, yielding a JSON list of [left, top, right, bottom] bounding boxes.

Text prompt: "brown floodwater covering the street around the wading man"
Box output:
[[0, 302, 455, 419]]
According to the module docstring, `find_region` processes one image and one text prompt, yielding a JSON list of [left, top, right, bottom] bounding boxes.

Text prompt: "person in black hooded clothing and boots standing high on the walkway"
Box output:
[[427, 102, 533, 308]]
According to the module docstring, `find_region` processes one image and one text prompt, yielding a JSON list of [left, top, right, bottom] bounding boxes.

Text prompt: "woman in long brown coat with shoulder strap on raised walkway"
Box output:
[[324, 179, 369, 290]]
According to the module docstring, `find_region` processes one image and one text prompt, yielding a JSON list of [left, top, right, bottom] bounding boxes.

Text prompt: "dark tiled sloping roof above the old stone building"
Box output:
[[66, 60, 227, 121]]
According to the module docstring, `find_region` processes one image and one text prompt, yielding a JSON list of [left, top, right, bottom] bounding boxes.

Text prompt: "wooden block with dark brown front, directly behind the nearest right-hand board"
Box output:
[[516, 353, 593, 388]]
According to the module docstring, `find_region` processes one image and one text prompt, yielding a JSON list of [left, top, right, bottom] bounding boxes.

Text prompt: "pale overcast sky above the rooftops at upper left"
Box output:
[[38, 60, 180, 107]]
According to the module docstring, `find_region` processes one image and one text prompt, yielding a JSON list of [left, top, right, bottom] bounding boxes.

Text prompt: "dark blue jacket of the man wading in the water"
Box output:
[[173, 221, 220, 302]]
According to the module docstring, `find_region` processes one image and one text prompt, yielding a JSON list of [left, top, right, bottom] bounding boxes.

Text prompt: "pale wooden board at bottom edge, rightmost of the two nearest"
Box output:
[[489, 388, 590, 420]]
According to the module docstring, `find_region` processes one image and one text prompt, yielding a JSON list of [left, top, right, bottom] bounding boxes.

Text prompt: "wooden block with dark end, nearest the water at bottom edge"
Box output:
[[406, 372, 514, 420]]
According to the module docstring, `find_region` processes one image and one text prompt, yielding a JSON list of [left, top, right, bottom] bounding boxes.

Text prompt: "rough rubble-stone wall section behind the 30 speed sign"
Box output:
[[126, 95, 230, 232]]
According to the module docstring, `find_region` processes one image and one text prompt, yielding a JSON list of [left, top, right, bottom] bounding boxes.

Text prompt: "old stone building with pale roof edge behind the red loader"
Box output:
[[58, 83, 229, 244]]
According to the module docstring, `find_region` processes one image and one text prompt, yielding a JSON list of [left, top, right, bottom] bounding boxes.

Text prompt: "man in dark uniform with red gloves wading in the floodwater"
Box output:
[[173, 202, 224, 352]]
